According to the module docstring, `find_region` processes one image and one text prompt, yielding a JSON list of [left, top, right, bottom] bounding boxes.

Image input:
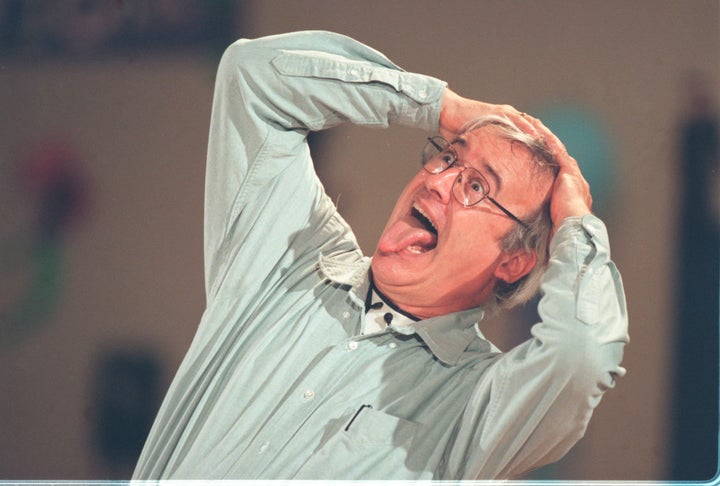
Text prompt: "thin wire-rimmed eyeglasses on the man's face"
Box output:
[[422, 137, 528, 229]]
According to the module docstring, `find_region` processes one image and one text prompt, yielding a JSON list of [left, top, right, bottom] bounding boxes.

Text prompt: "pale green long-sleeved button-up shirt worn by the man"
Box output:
[[135, 32, 628, 480]]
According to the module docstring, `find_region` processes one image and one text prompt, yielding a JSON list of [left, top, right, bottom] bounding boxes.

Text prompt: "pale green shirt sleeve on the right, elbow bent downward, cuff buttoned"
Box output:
[[448, 215, 629, 478]]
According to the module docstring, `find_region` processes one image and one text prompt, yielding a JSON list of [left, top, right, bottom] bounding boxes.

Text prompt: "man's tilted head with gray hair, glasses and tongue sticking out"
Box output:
[[372, 116, 557, 317]]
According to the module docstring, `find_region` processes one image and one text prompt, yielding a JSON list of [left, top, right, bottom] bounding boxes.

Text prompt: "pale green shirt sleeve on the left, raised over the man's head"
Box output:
[[205, 32, 445, 301]]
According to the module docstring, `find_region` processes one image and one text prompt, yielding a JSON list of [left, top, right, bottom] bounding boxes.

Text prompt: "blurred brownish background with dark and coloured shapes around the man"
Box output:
[[0, 0, 720, 480]]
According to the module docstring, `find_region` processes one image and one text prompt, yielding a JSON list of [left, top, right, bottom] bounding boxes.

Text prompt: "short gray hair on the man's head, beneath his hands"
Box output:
[[460, 115, 559, 311]]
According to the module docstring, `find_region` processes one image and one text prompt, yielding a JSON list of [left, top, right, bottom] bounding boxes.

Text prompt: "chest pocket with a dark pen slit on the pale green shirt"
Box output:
[[295, 407, 423, 480]]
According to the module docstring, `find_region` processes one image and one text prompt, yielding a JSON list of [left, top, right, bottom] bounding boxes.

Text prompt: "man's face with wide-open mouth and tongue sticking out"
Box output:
[[372, 126, 553, 318]]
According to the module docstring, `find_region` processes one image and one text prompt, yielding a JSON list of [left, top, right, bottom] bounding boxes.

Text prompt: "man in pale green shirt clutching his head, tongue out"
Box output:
[[135, 32, 627, 479]]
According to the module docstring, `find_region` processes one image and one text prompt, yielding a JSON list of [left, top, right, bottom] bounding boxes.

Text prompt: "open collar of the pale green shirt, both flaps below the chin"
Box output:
[[319, 253, 485, 366]]
